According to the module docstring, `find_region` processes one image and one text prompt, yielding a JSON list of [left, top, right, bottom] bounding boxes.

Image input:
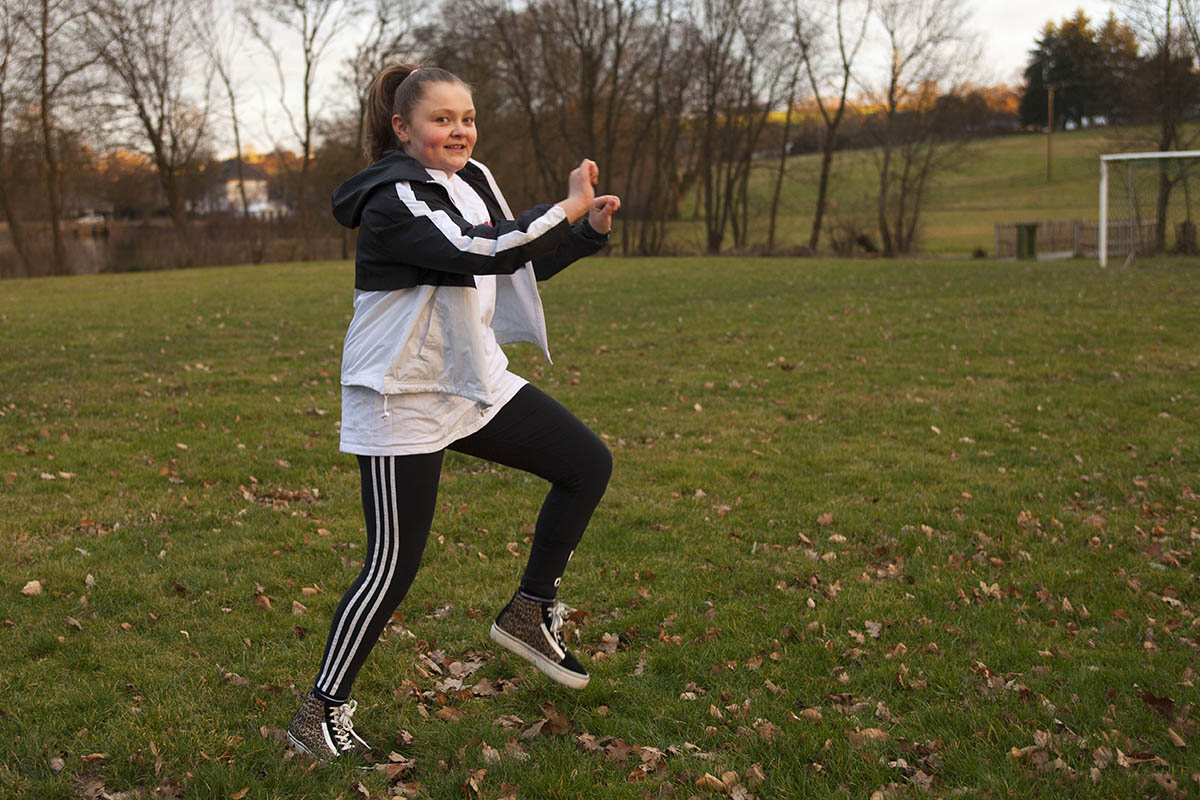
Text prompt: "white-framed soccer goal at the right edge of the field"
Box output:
[[1096, 150, 1200, 266]]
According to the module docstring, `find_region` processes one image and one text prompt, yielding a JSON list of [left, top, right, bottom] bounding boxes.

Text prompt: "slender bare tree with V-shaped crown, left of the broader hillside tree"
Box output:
[[792, 0, 874, 252]]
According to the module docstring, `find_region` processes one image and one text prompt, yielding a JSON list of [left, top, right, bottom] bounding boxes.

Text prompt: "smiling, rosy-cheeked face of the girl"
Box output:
[[391, 82, 476, 173]]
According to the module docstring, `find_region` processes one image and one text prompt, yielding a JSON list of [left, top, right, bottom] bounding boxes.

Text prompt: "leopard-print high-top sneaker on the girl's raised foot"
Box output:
[[491, 593, 589, 688]]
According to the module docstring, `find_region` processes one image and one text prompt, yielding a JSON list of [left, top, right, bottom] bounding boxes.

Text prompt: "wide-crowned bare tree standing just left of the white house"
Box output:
[[89, 0, 210, 264]]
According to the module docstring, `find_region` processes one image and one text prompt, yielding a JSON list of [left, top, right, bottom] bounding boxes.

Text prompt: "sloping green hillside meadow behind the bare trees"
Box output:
[[672, 128, 1182, 254]]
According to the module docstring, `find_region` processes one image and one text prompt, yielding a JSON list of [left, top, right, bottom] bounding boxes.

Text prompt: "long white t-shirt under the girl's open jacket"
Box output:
[[340, 169, 528, 456]]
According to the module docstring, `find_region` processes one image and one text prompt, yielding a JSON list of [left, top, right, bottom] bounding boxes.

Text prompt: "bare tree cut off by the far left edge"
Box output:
[[0, 1, 34, 275]]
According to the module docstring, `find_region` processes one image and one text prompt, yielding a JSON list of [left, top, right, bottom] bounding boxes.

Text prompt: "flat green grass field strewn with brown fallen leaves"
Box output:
[[0, 257, 1200, 800]]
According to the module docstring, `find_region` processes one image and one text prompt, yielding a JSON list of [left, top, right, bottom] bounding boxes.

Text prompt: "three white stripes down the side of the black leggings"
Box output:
[[317, 456, 400, 697]]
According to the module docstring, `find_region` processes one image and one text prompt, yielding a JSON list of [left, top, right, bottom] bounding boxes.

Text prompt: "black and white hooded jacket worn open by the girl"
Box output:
[[332, 150, 608, 405]]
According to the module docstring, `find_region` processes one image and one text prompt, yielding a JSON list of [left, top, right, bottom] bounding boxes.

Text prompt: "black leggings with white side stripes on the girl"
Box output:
[[316, 385, 612, 702]]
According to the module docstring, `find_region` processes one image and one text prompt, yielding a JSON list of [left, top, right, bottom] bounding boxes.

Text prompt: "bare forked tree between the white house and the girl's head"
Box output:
[[246, 0, 361, 258]]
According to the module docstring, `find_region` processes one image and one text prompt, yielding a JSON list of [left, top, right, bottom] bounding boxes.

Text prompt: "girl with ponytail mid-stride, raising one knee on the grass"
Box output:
[[280, 65, 620, 759]]
